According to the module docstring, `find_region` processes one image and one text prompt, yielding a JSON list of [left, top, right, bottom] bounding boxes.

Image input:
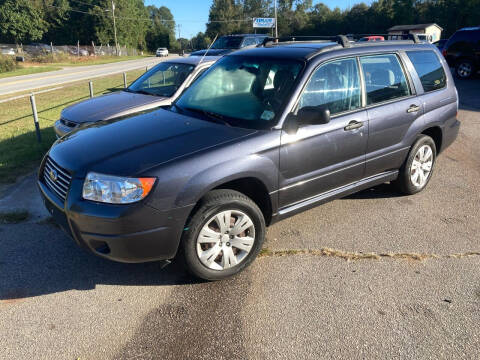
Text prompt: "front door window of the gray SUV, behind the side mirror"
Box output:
[[299, 59, 361, 115]]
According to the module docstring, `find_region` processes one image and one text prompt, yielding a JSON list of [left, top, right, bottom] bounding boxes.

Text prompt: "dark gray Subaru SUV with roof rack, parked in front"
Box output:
[[38, 36, 460, 280]]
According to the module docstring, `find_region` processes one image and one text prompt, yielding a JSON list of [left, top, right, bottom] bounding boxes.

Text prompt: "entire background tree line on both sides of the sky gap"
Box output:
[[0, 0, 480, 51]]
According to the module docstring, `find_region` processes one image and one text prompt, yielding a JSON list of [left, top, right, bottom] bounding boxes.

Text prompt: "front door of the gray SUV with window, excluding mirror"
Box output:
[[279, 58, 368, 208]]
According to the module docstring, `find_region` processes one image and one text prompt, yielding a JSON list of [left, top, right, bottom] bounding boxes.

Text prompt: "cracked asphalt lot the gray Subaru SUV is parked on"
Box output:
[[0, 80, 480, 360]]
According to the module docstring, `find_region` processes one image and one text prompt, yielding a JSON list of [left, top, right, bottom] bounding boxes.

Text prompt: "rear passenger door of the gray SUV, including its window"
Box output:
[[360, 53, 423, 177]]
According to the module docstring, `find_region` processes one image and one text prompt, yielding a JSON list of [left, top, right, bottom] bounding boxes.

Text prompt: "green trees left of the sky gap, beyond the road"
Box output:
[[0, 0, 179, 51]]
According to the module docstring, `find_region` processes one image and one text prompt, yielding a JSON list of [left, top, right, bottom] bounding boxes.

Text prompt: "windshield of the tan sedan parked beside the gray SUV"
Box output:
[[127, 62, 195, 97]]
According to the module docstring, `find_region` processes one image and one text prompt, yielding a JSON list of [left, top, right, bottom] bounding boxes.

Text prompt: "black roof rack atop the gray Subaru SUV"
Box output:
[[258, 34, 421, 48]]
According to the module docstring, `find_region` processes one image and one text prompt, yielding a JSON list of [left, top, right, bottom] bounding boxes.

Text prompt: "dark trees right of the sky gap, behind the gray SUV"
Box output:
[[192, 0, 480, 47]]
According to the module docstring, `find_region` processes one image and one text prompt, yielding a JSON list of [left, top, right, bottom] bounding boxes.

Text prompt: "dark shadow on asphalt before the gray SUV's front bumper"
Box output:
[[0, 222, 201, 300]]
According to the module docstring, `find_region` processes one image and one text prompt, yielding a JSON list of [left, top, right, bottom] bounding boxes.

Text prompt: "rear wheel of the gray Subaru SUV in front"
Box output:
[[393, 135, 437, 195]]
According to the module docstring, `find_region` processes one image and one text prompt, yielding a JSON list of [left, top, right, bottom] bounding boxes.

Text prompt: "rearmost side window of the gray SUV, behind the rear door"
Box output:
[[407, 51, 447, 92]]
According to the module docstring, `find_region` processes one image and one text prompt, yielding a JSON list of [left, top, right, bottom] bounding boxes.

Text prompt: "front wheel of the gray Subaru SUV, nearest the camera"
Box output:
[[181, 190, 266, 280]]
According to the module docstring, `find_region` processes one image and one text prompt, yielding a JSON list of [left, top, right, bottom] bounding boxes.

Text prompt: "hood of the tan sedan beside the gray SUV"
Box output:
[[62, 91, 168, 124]]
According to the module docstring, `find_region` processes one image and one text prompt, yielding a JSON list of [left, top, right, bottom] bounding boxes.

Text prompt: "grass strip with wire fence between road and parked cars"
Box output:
[[0, 70, 144, 183]]
